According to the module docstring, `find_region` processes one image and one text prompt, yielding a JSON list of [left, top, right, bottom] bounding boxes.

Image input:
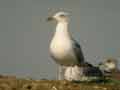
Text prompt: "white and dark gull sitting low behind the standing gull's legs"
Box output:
[[64, 62, 103, 82]]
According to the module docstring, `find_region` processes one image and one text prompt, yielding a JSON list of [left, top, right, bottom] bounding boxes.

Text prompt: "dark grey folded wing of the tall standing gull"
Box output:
[[73, 40, 84, 63]]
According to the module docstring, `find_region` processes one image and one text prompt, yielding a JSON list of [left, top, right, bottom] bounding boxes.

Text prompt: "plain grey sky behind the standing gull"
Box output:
[[0, 0, 120, 79]]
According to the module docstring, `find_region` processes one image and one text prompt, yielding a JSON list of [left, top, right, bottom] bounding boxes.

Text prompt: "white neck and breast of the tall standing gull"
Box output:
[[50, 23, 78, 65]]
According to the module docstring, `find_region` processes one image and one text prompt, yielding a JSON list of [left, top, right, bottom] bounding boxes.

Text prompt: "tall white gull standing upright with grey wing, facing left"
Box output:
[[47, 11, 84, 80]]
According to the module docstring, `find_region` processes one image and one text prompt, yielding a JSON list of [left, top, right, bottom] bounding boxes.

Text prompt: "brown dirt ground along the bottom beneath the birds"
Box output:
[[0, 76, 120, 90]]
